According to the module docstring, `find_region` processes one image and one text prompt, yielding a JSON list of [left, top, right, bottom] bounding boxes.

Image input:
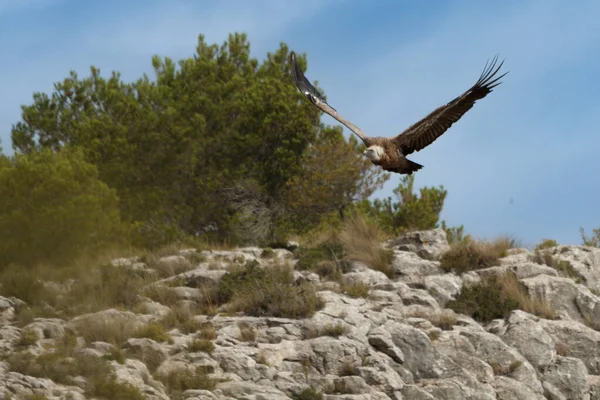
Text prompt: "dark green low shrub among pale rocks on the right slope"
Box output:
[[446, 279, 519, 322]]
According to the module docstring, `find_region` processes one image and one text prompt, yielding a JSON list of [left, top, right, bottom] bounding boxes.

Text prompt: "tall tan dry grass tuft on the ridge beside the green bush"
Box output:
[[339, 214, 393, 278]]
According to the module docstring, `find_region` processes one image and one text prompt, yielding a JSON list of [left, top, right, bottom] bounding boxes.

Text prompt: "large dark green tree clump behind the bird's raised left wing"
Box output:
[[12, 33, 383, 246]]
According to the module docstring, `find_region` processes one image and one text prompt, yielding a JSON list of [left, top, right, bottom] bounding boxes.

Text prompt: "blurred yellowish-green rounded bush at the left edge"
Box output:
[[0, 149, 123, 266]]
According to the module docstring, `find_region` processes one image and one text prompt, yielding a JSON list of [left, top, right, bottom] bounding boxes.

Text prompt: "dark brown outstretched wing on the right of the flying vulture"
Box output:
[[392, 55, 508, 155]]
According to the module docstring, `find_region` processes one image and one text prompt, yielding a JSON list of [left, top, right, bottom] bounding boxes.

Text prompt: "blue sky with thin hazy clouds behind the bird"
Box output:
[[0, 0, 600, 246]]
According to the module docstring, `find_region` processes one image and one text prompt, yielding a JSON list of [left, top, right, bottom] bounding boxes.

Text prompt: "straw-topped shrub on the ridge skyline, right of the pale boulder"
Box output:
[[440, 239, 510, 274]]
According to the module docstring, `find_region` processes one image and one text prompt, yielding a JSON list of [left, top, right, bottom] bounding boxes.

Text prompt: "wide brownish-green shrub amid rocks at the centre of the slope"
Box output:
[[215, 265, 324, 318]]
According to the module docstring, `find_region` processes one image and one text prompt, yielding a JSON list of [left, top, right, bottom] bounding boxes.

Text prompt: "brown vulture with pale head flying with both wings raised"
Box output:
[[290, 51, 508, 175]]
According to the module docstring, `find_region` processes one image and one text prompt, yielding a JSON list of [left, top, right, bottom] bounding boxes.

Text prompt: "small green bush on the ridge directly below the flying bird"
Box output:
[[355, 175, 446, 234]]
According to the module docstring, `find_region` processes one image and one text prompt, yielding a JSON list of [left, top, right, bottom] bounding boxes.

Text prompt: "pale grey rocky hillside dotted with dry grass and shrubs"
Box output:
[[0, 230, 600, 400]]
